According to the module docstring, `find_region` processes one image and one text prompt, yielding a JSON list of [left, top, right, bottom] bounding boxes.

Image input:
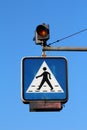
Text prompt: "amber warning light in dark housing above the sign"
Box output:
[[34, 24, 49, 46]]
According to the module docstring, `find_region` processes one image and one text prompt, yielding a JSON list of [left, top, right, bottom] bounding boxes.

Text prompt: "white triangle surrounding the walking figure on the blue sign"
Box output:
[[26, 61, 64, 93]]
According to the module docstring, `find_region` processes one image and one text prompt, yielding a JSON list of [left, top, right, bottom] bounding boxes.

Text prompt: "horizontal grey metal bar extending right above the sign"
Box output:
[[43, 47, 87, 51]]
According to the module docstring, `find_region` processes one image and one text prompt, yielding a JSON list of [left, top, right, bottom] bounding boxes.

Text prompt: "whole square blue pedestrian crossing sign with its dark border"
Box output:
[[22, 57, 68, 103]]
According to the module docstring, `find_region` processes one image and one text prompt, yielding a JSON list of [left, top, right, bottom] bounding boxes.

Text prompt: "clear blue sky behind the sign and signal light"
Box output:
[[0, 0, 87, 130]]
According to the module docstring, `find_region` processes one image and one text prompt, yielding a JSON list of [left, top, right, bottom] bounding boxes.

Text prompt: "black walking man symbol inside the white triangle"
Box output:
[[36, 67, 53, 90]]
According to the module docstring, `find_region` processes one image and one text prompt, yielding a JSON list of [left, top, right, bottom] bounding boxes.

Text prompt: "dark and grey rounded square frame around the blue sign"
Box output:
[[21, 56, 68, 104]]
